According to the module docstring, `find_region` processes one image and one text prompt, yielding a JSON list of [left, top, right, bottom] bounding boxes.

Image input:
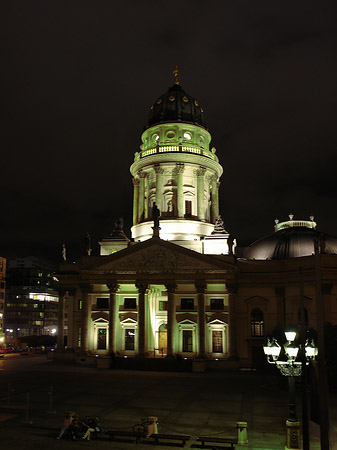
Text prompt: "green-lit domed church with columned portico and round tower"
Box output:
[[58, 73, 337, 365]]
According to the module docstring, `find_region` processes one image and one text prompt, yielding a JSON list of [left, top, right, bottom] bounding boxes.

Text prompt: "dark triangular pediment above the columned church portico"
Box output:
[[82, 239, 233, 273]]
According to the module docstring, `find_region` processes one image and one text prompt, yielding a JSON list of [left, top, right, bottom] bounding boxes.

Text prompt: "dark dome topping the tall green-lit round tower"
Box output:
[[148, 83, 207, 129]]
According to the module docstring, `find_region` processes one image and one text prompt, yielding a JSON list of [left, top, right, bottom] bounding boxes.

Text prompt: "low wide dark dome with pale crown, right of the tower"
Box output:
[[244, 215, 337, 260]]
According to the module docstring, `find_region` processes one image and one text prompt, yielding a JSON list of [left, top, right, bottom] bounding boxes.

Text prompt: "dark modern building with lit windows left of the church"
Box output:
[[5, 257, 58, 340]]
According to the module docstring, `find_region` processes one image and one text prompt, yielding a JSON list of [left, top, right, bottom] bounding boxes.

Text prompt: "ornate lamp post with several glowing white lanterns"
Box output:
[[263, 331, 317, 450]]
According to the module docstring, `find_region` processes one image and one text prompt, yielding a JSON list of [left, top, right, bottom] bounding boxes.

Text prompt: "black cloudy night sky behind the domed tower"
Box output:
[[0, 0, 337, 260]]
